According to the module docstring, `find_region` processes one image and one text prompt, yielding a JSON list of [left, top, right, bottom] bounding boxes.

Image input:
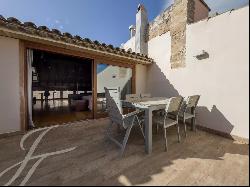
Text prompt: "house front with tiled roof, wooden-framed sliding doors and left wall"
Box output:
[[0, 16, 153, 134]]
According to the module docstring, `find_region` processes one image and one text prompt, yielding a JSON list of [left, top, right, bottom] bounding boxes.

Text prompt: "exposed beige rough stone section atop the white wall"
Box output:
[[147, 0, 208, 68]]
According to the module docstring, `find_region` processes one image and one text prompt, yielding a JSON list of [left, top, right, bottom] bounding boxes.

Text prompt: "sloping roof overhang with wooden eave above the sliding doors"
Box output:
[[0, 16, 153, 65]]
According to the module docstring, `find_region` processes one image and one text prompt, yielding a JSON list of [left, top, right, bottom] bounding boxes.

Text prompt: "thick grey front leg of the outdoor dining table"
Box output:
[[145, 109, 152, 154]]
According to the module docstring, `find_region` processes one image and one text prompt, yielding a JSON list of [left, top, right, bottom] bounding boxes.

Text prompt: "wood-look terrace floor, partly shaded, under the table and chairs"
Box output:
[[0, 118, 249, 185]]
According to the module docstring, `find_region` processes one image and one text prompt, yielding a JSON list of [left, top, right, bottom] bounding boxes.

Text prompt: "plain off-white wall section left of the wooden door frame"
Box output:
[[0, 36, 20, 134]]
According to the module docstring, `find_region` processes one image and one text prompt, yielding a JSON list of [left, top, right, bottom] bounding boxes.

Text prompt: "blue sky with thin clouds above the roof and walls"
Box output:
[[0, 0, 249, 46]]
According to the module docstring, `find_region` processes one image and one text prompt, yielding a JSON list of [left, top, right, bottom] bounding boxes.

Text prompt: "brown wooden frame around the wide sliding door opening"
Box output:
[[19, 40, 136, 131]]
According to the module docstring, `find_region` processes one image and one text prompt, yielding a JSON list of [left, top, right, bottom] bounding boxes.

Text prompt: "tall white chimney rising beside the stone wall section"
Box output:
[[135, 4, 148, 55]]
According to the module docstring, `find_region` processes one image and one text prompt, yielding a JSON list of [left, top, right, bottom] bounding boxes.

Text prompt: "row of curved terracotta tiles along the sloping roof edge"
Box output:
[[0, 15, 153, 63]]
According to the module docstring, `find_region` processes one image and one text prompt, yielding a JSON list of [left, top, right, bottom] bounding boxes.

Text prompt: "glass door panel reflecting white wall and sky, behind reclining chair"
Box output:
[[96, 64, 133, 117]]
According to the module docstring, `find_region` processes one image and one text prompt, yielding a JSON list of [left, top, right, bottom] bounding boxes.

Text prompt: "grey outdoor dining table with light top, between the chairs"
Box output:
[[124, 97, 169, 154]]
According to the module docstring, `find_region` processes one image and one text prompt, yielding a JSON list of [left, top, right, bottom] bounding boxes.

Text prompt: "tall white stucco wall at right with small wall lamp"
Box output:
[[147, 7, 249, 138]]
